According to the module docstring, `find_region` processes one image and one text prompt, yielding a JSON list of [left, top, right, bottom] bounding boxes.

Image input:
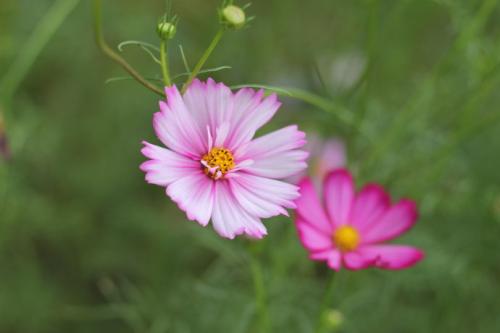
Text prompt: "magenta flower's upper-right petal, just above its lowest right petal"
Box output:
[[362, 199, 418, 244]]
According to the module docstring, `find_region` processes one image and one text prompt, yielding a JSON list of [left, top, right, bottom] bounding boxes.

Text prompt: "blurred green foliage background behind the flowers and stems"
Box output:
[[0, 0, 500, 333]]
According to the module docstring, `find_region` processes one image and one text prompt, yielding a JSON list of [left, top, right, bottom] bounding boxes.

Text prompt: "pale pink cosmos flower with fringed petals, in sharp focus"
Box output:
[[141, 79, 307, 238]]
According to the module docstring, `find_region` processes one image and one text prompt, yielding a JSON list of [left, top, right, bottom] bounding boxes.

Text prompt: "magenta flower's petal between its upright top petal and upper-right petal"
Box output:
[[349, 184, 391, 232]]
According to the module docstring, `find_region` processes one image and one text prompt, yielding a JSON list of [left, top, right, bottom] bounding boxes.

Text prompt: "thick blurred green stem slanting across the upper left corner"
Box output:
[[0, 0, 79, 104]]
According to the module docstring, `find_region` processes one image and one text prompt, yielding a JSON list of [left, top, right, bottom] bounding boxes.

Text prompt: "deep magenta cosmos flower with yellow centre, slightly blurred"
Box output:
[[295, 169, 424, 270]]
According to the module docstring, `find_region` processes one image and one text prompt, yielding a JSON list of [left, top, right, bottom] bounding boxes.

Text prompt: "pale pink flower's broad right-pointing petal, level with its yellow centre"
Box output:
[[235, 126, 308, 179]]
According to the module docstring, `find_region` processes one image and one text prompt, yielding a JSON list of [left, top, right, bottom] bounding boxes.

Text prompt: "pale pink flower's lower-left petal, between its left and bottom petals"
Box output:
[[167, 172, 215, 226]]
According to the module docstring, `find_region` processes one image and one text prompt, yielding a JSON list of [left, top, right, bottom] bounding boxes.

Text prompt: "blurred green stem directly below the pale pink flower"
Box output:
[[250, 246, 271, 333]]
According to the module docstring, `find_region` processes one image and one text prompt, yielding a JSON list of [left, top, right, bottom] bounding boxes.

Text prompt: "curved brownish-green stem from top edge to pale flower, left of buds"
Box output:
[[94, 0, 165, 96]]
